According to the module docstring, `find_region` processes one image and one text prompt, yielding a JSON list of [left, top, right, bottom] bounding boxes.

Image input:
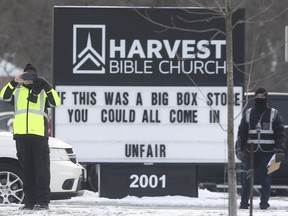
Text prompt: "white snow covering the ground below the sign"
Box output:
[[0, 190, 288, 216]]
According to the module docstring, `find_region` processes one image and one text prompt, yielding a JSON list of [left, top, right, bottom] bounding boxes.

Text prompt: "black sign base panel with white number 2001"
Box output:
[[99, 164, 198, 199]]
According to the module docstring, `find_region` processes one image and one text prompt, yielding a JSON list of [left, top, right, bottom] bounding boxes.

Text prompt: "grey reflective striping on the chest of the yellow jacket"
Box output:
[[14, 88, 48, 118]]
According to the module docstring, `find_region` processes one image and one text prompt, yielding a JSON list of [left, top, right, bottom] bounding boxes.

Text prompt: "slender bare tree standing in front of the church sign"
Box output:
[[132, 0, 242, 216]]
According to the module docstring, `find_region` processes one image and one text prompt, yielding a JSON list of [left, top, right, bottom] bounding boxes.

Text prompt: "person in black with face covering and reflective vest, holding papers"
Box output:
[[236, 87, 286, 209]]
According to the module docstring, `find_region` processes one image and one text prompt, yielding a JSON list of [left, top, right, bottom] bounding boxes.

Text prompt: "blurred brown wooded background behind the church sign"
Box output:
[[0, 0, 288, 88]]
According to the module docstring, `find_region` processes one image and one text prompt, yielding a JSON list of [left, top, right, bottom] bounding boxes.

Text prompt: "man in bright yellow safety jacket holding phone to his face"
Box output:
[[0, 64, 60, 210]]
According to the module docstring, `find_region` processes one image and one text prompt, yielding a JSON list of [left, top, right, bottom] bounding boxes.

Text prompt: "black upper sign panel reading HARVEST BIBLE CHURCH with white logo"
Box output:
[[53, 7, 244, 86]]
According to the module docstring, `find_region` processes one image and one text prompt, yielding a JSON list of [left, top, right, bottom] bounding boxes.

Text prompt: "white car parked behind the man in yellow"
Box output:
[[0, 131, 87, 204]]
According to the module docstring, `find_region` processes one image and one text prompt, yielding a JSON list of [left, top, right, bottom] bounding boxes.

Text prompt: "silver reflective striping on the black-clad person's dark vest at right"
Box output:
[[246, 108, 277, 145]]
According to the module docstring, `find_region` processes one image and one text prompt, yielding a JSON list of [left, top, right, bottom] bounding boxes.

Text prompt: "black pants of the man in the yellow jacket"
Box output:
[[16, 137, 50, 205]]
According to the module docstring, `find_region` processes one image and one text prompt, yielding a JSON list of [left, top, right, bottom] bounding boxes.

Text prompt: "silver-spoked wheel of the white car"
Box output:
[[0, 163, 24, 204]]
